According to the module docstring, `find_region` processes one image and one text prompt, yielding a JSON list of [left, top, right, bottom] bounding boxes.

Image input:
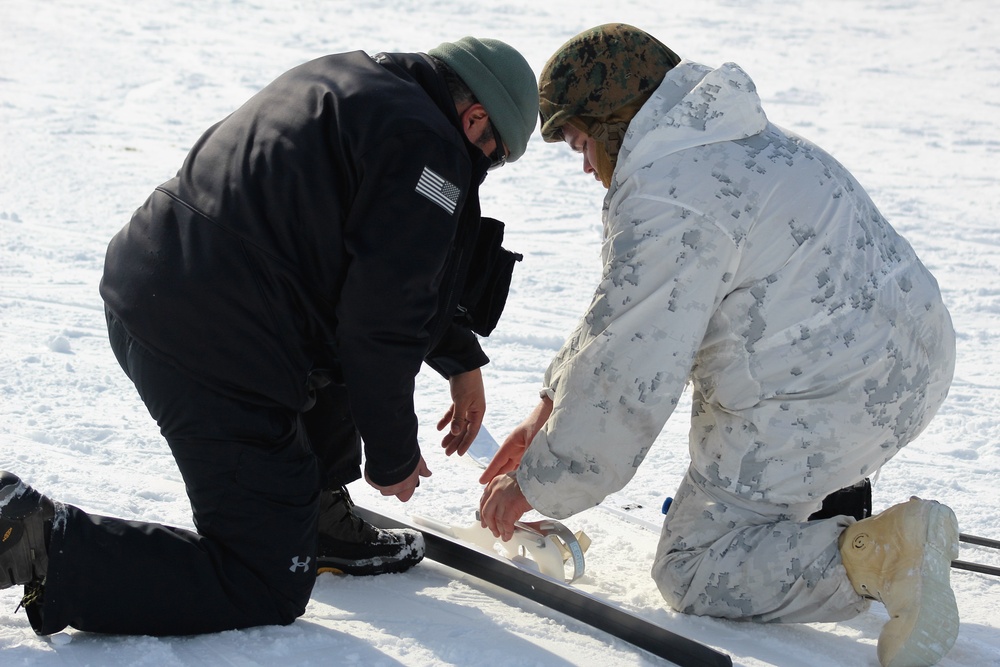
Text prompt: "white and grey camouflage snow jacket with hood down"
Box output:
[[517, 61, 954, 518]]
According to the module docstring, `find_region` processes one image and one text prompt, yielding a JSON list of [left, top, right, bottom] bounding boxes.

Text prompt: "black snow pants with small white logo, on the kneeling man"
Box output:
[[29, 312, 361, 635]]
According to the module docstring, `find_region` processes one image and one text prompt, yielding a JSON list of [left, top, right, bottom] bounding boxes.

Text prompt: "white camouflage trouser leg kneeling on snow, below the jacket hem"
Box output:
[[652, 469, 869, 623]]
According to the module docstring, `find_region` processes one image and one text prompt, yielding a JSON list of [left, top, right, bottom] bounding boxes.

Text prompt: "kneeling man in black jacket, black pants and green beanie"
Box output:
[[0, 37, 538, 635]]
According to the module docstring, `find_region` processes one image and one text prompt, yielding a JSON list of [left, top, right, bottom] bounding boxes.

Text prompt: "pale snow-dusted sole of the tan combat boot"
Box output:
[[879, 500, 959, 667]]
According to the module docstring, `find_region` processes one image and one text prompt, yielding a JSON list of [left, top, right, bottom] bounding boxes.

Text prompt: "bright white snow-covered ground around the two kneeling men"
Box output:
[[0, 0, 1000, 667]]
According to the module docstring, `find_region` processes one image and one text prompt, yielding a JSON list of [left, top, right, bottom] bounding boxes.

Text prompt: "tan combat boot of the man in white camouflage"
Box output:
[[840, 497, 958, 667]]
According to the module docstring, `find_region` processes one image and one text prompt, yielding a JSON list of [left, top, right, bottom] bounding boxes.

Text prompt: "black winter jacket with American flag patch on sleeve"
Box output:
[[101, 52, 489, 485]]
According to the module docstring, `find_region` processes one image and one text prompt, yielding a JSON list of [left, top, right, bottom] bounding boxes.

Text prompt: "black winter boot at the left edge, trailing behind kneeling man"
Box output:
[[0, 470, 55, 589]]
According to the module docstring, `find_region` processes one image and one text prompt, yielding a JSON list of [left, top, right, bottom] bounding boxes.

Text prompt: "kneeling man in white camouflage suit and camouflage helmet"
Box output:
[[481, 24, 958, 667]]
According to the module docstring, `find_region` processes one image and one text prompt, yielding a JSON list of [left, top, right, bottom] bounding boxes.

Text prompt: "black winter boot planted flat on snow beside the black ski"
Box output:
[[316, 486, 424, 575]]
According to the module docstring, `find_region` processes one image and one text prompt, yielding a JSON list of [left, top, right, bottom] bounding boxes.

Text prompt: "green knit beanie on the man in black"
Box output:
[[427, 37, 538, 162]]
